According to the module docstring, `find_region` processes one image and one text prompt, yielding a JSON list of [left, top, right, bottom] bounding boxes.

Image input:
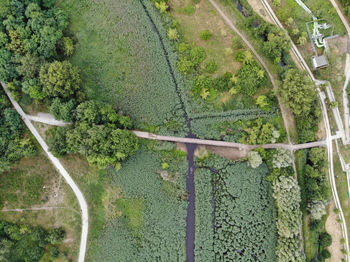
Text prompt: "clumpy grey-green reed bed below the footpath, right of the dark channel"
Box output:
[[196, 157, 277, 261]]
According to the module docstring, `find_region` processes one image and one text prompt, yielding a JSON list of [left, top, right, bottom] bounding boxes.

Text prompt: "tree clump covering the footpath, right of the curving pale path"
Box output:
[[48, 101, 138, 168]]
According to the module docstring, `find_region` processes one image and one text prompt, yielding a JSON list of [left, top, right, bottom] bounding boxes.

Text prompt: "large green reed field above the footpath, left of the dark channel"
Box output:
[[58, 0, 186, 126]]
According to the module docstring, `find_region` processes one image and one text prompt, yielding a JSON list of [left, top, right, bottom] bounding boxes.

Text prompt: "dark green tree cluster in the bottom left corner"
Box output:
[[0, 221, 66, 262]]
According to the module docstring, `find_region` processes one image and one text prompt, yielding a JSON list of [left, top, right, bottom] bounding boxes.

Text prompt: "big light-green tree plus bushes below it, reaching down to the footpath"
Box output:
[[280, 68, 321, 142]]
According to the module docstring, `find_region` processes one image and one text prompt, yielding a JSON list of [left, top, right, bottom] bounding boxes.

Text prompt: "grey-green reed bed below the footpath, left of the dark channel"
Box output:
[[90, 149, 187, 261]]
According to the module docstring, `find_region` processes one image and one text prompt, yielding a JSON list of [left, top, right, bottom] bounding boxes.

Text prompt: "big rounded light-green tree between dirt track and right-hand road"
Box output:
[[280, 69, 316, 115]]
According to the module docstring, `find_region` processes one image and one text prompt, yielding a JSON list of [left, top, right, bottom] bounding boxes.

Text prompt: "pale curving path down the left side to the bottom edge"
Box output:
[[1, 83, 89, 262]]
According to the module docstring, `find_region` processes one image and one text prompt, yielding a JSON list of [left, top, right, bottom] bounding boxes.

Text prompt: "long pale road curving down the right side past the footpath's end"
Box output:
[[261, 0, 350, 261]]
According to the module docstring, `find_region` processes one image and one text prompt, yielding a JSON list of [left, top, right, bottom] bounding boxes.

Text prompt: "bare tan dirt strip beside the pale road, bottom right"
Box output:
[[326, 201, 344, 262]]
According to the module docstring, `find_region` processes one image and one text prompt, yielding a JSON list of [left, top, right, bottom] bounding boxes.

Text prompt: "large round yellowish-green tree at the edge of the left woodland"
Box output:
[[40, 61, 81, 99]]
